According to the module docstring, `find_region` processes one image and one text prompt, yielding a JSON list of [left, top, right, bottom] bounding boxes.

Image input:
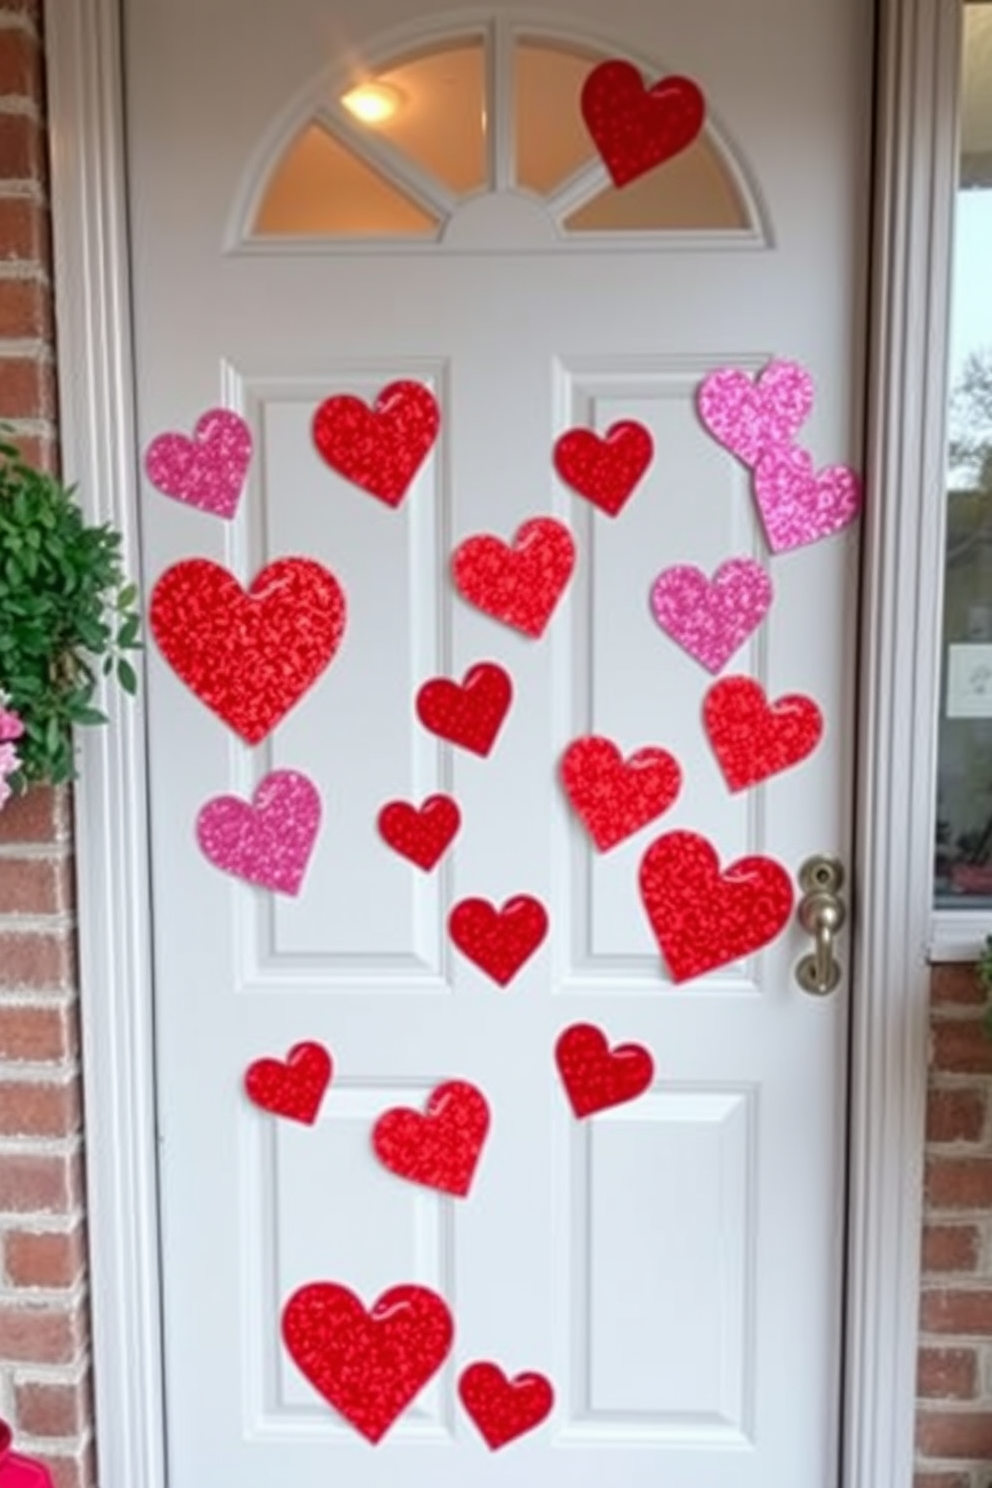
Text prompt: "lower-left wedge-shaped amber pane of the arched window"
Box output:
[[254, 124, 439, 238]]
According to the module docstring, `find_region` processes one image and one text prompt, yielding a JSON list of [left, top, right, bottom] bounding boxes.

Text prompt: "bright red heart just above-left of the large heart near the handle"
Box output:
[[561, 734, 683, 853]]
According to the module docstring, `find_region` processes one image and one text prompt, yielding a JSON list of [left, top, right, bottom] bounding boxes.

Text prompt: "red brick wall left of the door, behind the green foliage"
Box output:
[[0, 0, 92, 1488]]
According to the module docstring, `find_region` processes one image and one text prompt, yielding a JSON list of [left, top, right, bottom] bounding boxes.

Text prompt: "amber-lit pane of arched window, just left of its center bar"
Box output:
[[349, 40, 489, 196]]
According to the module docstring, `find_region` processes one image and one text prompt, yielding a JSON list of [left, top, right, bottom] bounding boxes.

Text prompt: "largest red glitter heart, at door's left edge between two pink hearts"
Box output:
[[149, 558, 347, 744]]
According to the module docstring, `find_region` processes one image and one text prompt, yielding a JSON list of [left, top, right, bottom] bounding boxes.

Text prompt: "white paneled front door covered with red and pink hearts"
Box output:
[[125, 0, 870, 1488]]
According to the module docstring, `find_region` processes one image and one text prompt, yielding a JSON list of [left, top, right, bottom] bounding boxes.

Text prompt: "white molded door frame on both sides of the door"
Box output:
[[46, 0, 964, 1488]]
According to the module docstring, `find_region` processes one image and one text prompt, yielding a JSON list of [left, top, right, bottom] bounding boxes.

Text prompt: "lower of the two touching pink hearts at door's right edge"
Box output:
[[754, 445, 861, 554]]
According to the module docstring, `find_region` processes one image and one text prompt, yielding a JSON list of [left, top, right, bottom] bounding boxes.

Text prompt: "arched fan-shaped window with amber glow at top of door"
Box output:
[[241, 27, 766, 247]]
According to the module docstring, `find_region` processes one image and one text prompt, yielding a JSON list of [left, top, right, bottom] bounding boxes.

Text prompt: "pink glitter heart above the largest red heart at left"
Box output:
[[144, 408, 251, 518]]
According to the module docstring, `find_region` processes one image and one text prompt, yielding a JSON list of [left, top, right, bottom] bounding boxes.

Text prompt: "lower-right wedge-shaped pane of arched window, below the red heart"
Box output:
[[565, 137, 748, 232]]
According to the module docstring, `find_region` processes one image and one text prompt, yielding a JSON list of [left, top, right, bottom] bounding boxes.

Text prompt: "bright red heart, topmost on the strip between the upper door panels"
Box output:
[[452, 516, 576, 638]]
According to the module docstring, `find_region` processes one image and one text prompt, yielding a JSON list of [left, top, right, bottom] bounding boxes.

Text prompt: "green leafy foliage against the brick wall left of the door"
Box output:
[[0, 442, 141, 789]]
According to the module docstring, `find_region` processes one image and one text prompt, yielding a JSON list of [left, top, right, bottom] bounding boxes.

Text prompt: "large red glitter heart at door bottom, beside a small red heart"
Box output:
[[283, 1281, 455, 1442]]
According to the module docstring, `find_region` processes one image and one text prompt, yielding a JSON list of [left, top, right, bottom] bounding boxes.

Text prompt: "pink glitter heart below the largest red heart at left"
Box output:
[[196, 769, 320, 894]]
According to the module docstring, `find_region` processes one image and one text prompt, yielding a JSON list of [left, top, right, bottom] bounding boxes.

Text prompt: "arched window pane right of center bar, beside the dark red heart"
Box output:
[[513, 42, 602, 196]]
